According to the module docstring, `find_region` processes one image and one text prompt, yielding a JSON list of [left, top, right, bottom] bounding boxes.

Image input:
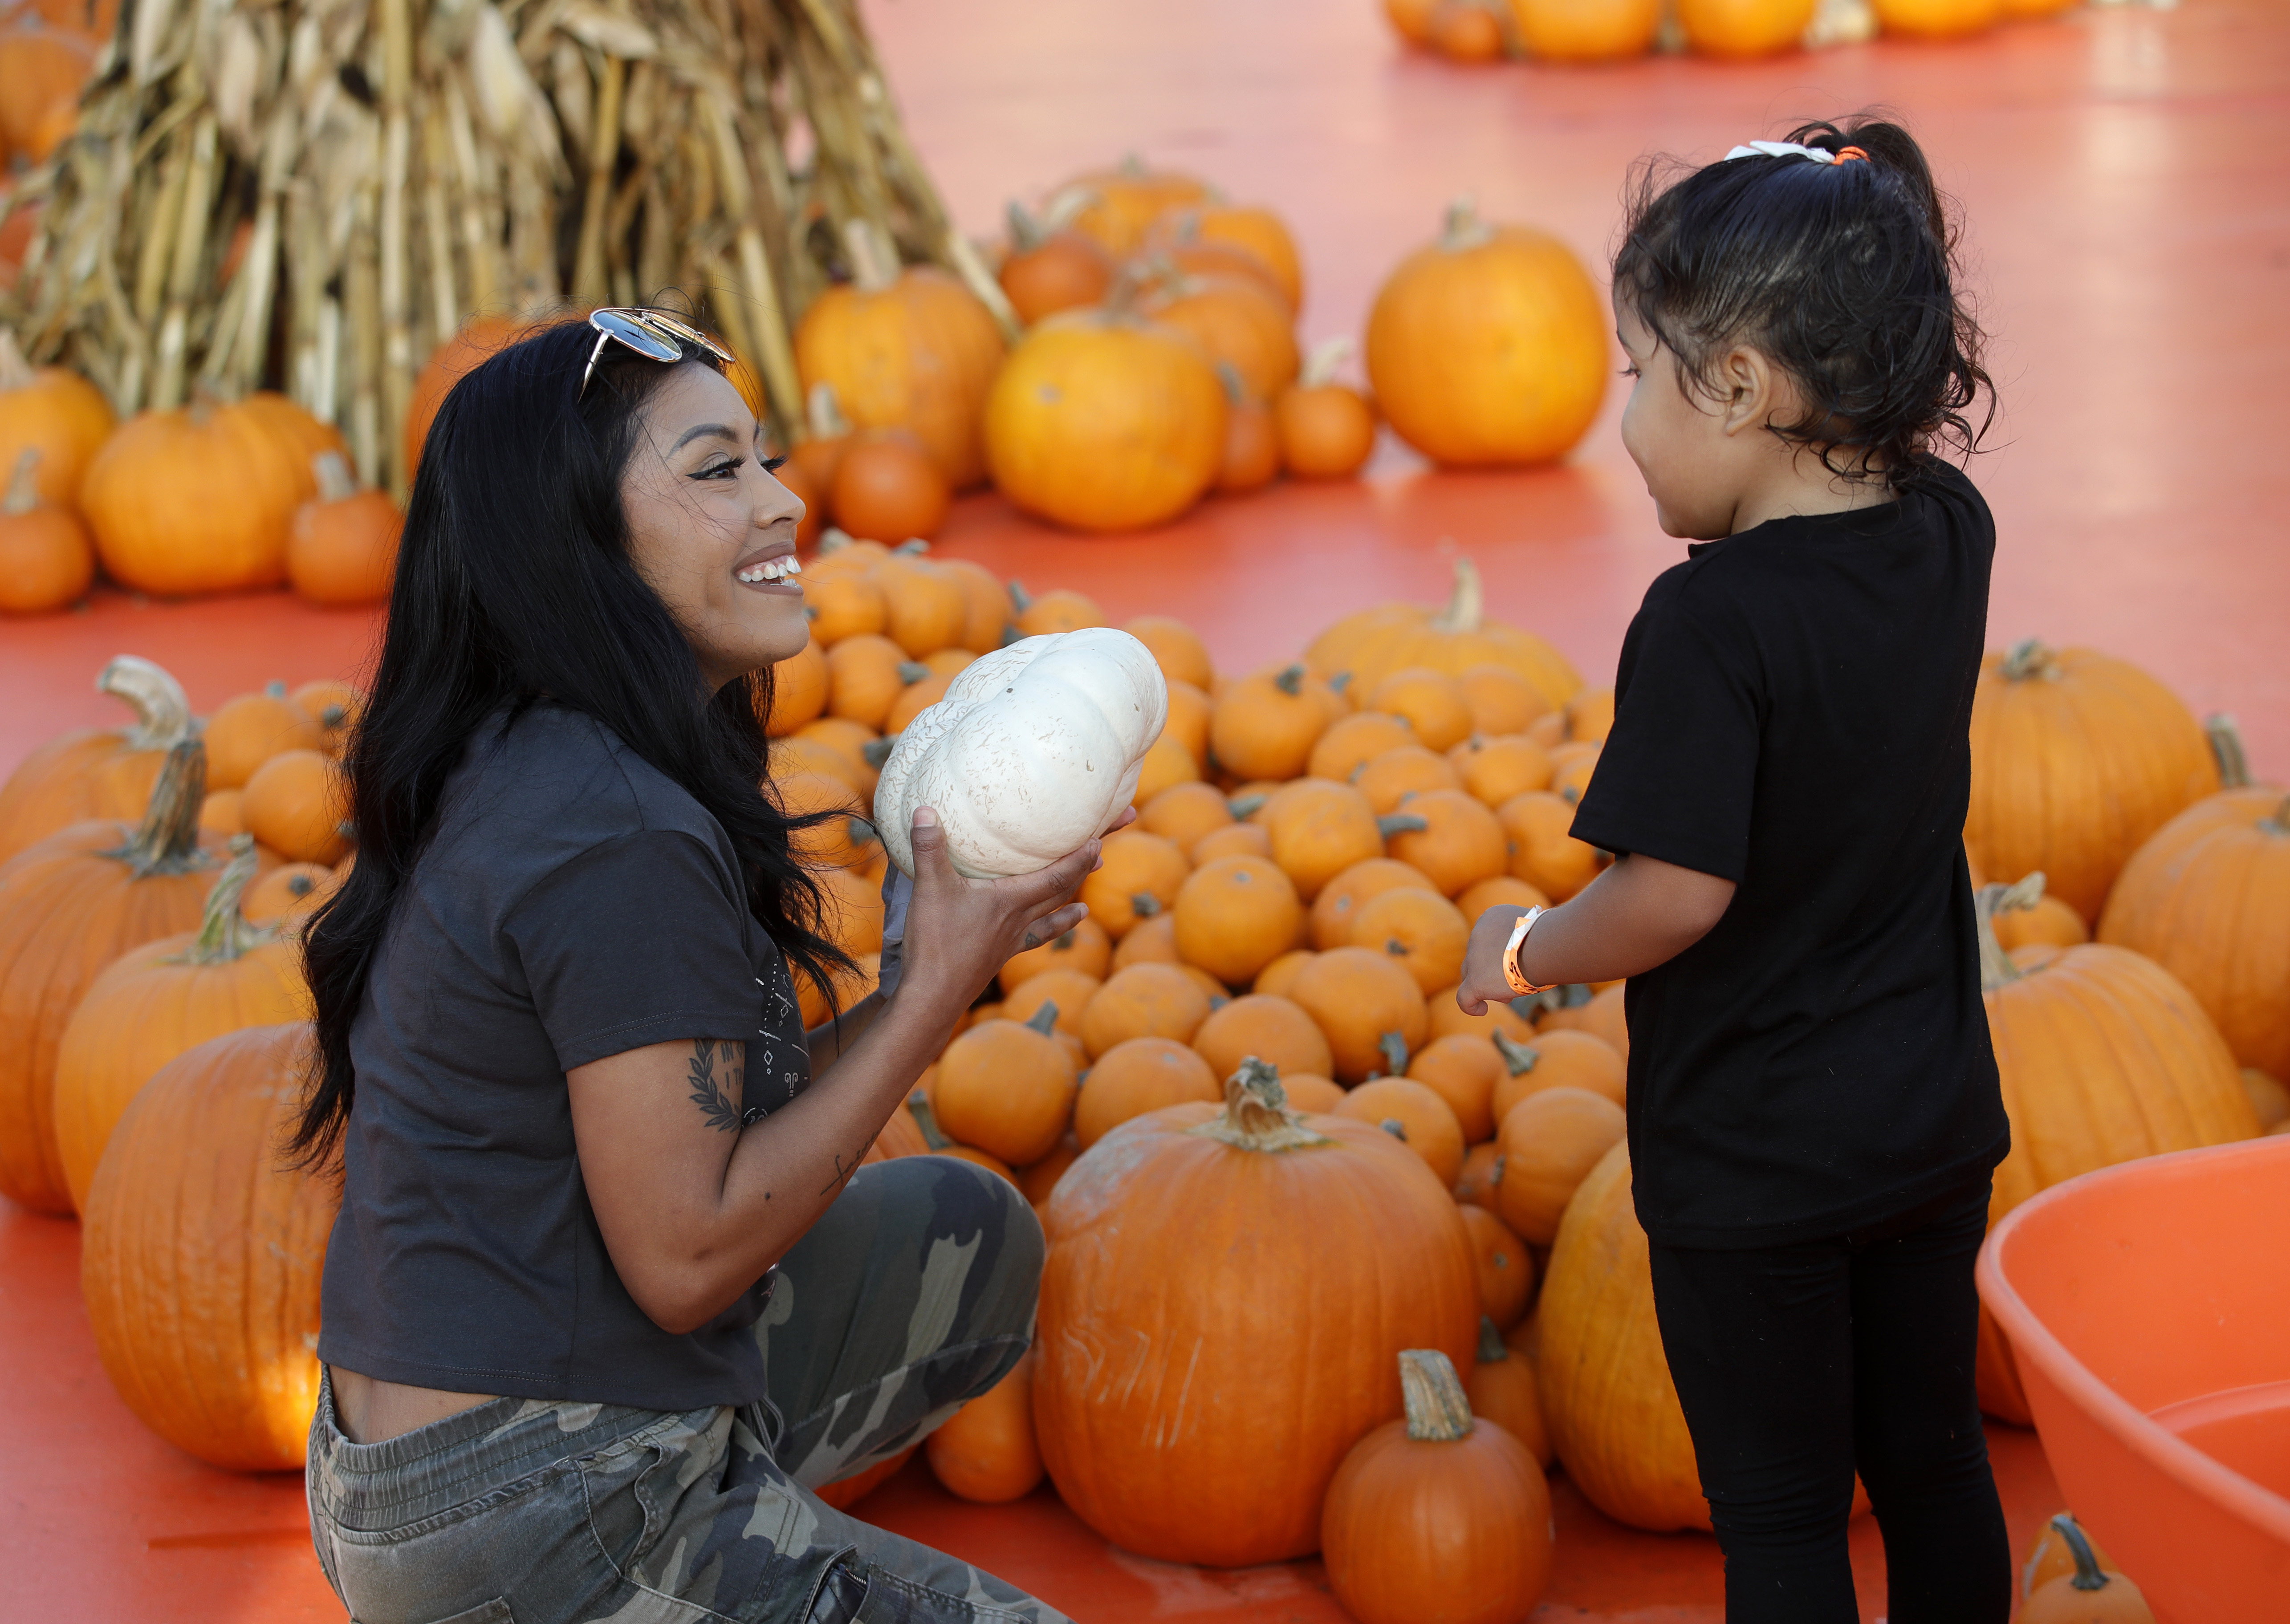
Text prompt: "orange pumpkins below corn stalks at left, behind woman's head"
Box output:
[[0, 330, 401, 614]]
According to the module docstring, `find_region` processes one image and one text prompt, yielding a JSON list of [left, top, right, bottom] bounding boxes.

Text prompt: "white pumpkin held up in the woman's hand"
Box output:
[[875, 625, 1168, 880]]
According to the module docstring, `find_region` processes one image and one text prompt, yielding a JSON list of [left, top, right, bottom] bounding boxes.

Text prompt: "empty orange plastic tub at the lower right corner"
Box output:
[[1979, 1136, 2290, 1624]]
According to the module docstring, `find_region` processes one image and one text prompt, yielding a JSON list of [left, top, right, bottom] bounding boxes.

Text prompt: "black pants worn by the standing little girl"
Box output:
[[1651, 1180, 2011, 1624]]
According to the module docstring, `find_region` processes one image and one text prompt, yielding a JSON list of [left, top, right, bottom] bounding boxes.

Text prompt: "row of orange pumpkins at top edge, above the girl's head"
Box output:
[[1383, 0, 2079, 62]]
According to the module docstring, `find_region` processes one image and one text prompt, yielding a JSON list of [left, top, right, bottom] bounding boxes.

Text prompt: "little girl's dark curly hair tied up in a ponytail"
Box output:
[[1615, 117, 1995, 488]]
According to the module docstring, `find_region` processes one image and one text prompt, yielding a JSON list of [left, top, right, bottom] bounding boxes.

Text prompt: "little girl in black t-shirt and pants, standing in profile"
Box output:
[[1459, 122, 2011, 1624]]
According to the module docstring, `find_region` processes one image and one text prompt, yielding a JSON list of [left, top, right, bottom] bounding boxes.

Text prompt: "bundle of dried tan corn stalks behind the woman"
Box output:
[[0, 0, 1008, 495]]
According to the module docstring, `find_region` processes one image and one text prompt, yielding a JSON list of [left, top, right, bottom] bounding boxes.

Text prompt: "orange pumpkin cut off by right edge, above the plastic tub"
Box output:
[[2100, 740, 2290, 1076]]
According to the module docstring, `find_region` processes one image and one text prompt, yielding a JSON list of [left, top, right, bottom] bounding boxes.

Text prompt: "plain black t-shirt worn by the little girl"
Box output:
[[1573, 467, 2011, 1246]]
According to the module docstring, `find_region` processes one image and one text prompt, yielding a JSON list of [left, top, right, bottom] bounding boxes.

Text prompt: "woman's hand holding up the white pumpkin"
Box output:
[[900, 806, 1136, 1008]]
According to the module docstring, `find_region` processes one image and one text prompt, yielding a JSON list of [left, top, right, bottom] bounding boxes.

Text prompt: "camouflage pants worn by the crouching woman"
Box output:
[[307, 1157, 1062, 1624]]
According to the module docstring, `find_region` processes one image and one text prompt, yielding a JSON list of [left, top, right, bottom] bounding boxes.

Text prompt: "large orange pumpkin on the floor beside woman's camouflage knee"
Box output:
[[1033, 1068, 1479, 1567]]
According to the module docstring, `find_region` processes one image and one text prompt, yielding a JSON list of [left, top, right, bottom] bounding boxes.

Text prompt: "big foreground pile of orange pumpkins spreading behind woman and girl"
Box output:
[[0, 534, 2290, 1620]]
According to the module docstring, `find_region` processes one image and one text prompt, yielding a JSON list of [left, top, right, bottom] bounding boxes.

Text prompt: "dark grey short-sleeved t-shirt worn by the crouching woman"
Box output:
[[318, 703, 811, 1411]]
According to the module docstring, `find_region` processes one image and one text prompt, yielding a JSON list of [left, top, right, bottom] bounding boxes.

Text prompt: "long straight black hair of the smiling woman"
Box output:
[[289, 321, 850, 1166]]
